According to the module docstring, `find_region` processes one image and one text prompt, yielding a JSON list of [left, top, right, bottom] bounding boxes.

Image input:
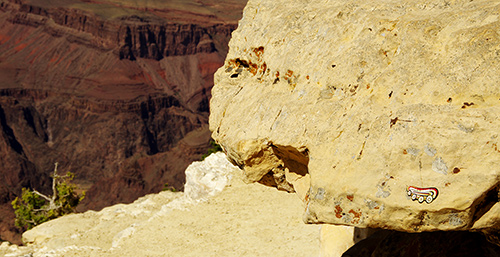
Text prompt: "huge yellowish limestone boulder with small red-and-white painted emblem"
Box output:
[[210, 0, 500, 232]]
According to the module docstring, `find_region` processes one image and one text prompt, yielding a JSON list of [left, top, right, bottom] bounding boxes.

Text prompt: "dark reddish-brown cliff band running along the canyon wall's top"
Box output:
[[0, 0, 236, 60]]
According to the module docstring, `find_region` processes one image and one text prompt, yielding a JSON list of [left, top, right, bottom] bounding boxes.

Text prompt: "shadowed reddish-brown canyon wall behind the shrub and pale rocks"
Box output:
[[0, 0, 246, 242]]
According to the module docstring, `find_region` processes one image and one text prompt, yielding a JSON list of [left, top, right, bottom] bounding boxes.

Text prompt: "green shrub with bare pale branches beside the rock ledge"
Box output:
[[11, 163, 85, 231]]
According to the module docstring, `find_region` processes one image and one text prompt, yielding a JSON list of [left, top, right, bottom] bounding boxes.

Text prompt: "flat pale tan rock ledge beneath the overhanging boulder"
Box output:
[[0, 153, 319, 256]]
